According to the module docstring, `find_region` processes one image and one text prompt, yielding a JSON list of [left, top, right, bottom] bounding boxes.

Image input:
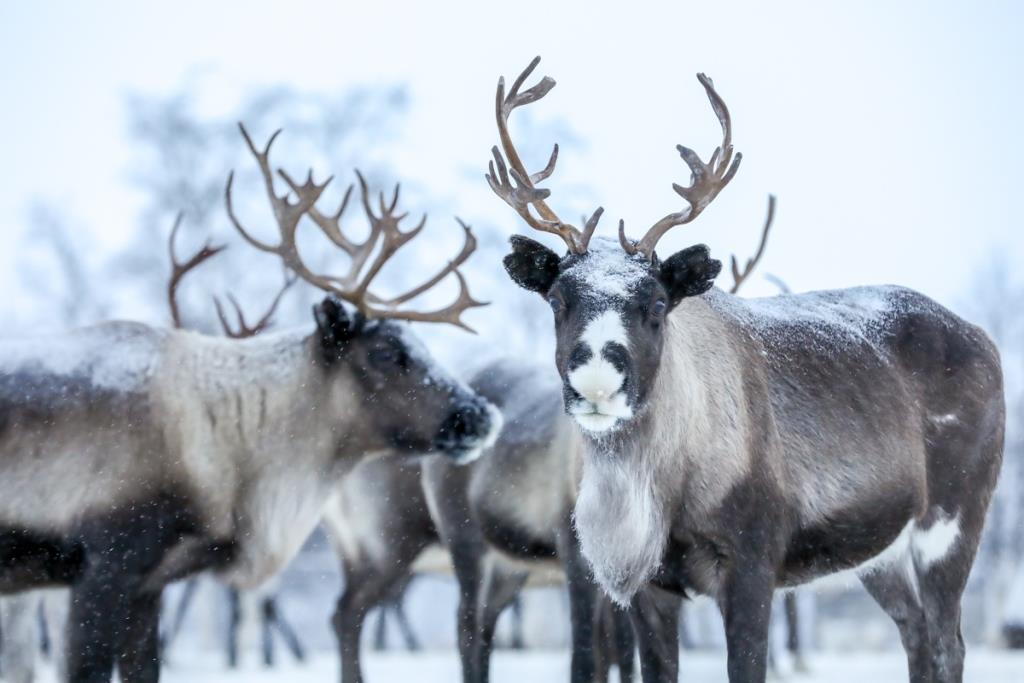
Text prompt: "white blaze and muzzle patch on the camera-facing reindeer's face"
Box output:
[[568, 310, 633, 433]]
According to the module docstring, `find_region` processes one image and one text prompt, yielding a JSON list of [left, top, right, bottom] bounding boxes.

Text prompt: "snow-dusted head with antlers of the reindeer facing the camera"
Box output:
[[486, 57, 767, 434]]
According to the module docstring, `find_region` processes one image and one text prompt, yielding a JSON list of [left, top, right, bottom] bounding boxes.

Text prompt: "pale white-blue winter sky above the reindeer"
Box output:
[[0, 1, 1024, 331]]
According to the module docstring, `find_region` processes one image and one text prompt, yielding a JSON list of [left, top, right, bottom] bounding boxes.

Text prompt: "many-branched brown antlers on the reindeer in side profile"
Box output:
[[224, 123, 485, 332]]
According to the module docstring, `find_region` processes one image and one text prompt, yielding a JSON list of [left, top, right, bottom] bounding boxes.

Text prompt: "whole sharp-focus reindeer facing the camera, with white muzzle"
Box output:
[[486, 59, 1006, 683]]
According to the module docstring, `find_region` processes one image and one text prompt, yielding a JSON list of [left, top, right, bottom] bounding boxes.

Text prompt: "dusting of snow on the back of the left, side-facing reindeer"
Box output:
[[0, 322, 163, 390]]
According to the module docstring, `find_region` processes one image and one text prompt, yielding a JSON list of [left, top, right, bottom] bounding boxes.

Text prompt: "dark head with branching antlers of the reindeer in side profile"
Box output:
[[218, 126, 501, 462]]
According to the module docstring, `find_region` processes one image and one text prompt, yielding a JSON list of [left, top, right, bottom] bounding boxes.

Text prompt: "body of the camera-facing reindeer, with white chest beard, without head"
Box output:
[[575, 287, 1005, 681]]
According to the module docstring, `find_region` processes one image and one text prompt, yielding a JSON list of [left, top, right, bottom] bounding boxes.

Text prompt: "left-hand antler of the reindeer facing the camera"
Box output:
[[484, 56, 604, 254]]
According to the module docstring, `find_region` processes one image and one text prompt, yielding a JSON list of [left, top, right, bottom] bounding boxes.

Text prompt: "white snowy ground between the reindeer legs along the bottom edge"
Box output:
[[22, 650, 1024, 683]]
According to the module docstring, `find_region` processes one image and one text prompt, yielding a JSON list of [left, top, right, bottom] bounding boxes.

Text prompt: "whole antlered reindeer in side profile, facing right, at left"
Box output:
[[0, 128, 501, 682]]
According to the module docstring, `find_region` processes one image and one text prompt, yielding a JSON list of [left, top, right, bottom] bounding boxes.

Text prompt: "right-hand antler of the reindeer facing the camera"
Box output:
[[618, 74, 743, 259]]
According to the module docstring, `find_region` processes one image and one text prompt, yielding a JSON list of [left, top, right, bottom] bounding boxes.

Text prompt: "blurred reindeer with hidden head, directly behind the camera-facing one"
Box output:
[[423, 359, 634, 683]]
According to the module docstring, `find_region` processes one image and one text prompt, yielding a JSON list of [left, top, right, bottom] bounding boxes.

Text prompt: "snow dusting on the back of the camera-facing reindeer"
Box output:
[[706, 285, 937, 360]]
